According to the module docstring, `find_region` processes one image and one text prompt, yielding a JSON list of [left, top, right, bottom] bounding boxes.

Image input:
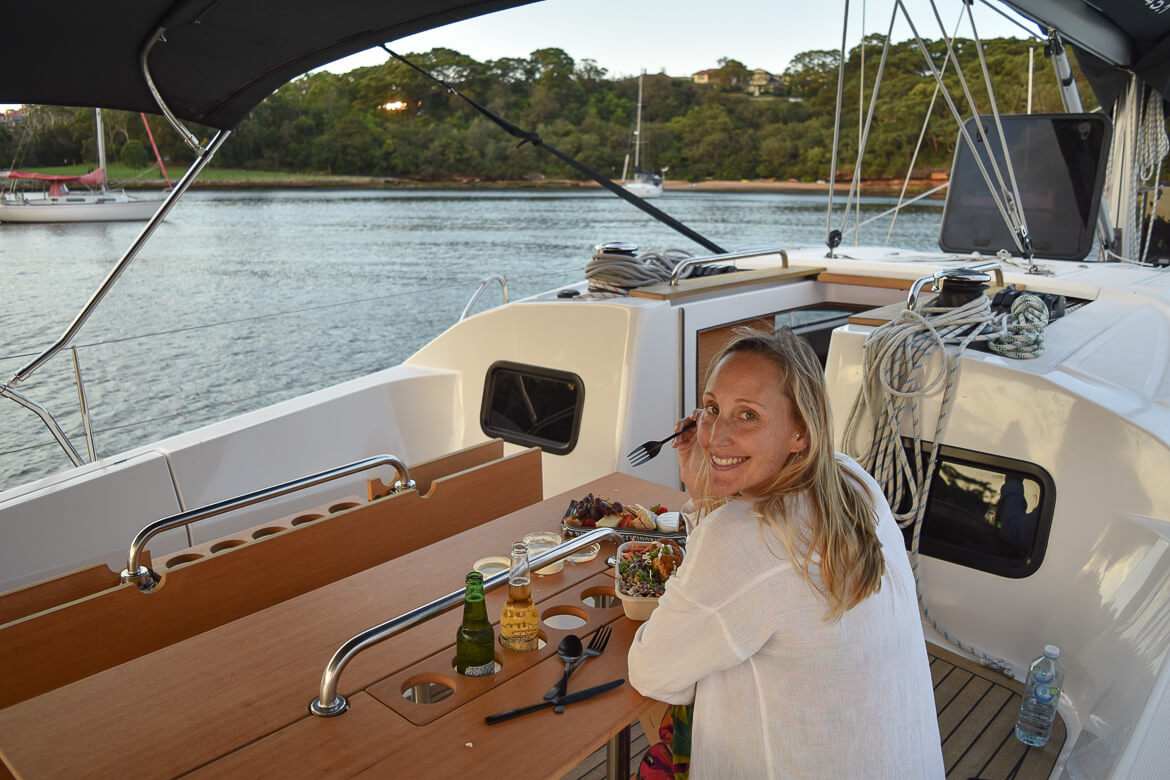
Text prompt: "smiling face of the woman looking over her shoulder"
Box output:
[[698, 352, 807, 497]]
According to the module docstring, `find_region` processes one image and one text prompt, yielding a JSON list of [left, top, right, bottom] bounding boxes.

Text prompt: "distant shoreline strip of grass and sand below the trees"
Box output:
[[132, 175, 945, 198]]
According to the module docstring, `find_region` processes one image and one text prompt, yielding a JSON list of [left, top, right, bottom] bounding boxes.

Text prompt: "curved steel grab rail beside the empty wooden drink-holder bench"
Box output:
[[122, 455, 414, 593]]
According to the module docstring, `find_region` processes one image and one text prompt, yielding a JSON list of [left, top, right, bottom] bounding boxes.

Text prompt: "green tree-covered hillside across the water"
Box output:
[[0, 36, 1096, 180]]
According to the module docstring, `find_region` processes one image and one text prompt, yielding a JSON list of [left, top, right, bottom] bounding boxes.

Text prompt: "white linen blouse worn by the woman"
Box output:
[[629, 455, 944, 780]]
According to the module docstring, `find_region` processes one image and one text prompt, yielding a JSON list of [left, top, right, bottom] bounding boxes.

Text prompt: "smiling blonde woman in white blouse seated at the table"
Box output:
[[629, 329, 944, 780]]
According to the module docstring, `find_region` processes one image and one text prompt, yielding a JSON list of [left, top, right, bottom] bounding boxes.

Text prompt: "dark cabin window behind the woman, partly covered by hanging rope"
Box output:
[[899, 442, 1057, 578]]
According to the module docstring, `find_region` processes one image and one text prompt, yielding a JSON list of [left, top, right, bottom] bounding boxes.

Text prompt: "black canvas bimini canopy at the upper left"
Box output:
[[0, 0, 532, 129]]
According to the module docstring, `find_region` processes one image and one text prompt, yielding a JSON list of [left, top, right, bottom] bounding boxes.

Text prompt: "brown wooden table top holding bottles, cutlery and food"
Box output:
[[0, 474, 684, 778]]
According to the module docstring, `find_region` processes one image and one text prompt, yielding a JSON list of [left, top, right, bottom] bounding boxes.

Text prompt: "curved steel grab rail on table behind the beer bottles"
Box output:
[[309, 529, 622, 718]]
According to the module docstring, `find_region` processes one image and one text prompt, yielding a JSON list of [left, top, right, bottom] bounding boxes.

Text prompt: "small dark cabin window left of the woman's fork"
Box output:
[[480, 361, 585, 455]]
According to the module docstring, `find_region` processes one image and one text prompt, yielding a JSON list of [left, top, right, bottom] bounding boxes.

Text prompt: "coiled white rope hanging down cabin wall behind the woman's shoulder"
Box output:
[[844, 295, 1048, 677]]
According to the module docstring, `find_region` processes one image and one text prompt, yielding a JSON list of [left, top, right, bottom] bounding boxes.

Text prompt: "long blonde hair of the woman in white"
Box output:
[[696, 327, 886, 621]]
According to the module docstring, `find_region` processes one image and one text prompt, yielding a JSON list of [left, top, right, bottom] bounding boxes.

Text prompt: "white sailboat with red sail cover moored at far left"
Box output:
[[0, 109, 170, 222]]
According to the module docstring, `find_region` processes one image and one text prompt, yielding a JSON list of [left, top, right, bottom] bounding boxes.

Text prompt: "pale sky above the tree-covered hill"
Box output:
[[0, 0, 1035, 110]]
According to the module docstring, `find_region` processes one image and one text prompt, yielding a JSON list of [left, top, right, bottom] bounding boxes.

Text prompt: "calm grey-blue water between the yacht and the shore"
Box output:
[[0, 191, 942, 490]]
